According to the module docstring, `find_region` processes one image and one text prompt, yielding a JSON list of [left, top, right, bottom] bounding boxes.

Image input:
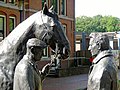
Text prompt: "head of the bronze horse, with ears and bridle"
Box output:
[[35, 4, 70, 59]]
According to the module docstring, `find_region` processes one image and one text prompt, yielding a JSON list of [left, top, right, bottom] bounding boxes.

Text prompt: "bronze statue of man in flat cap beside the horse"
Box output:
[[13, 38, 52, 90]]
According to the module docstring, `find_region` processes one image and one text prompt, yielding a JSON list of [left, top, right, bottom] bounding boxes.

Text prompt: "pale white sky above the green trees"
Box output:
[[75, 0, 120, 18]]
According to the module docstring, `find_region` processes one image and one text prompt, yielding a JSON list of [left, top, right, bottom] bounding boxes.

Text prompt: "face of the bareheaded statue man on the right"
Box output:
[[88, 38, 100, 56]]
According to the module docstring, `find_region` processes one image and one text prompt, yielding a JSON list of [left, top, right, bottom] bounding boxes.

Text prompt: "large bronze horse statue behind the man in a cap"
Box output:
[[0, 4, 70, 90]]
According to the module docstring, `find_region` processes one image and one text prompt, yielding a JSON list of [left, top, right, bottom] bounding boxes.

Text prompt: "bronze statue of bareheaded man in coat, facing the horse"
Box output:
[[87, 33, 118, 90]]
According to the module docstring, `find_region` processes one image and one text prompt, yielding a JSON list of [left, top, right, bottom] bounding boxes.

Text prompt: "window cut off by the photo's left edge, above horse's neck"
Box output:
[[0, 15, 5, 41]]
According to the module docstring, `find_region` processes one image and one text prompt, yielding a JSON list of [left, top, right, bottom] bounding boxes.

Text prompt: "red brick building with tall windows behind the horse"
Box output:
[[0, 0, 75, 69]]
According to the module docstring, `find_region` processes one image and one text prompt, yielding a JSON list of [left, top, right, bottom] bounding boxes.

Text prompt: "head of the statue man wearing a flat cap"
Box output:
[[27, 38, 47, 61]]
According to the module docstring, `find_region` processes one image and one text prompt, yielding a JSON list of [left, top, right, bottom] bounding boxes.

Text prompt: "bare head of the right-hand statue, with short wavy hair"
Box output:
[[88, 33, 110, 56]]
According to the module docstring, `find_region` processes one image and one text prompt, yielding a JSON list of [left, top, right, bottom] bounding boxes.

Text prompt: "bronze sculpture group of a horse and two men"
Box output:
[[0, 1, 117, 90]]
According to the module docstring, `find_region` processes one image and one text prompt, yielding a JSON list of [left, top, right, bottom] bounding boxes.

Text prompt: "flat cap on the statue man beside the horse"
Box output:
[[27, 38, 47, 48]]
